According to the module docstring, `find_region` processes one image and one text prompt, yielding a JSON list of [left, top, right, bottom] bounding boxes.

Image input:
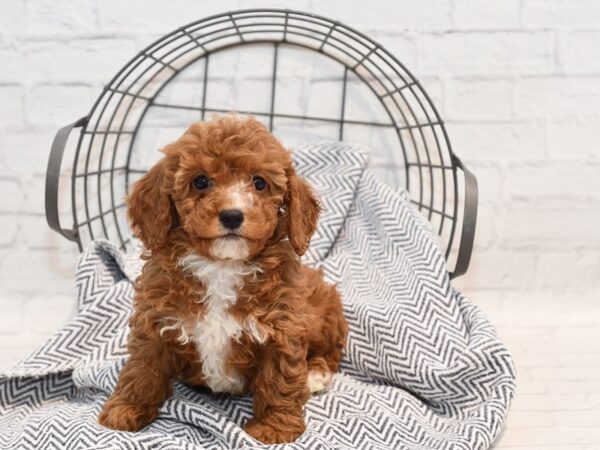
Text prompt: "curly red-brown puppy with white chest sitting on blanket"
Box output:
[[99, 116, 347, 443]]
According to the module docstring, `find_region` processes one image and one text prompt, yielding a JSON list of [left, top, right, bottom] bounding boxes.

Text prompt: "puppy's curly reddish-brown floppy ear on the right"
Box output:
[[285, 167, 321, 255]]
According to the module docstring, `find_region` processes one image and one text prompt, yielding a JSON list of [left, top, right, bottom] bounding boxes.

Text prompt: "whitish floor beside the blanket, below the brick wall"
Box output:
[[0, 292, 600, 450]]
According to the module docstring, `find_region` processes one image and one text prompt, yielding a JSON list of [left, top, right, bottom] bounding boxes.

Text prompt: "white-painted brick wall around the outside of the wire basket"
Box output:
[[0, 0, 600, 388]]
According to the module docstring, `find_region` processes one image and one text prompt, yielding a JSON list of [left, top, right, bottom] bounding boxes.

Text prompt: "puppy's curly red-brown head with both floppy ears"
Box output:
[[128, 116, 320, 260]]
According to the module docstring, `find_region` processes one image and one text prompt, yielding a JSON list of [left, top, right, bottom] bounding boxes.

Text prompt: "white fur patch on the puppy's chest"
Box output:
[[172, 253, 260, 393]]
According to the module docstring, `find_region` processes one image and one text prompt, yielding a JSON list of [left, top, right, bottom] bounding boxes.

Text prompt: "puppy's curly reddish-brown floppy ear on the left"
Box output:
[[127, 158, 172, 251]]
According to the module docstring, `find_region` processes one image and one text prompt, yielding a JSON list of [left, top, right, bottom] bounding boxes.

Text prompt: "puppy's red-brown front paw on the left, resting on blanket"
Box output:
[[98, 399, 158, 431]]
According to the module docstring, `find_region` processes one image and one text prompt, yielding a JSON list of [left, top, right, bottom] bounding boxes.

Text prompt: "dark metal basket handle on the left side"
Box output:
[[46, 117, 89, 242]]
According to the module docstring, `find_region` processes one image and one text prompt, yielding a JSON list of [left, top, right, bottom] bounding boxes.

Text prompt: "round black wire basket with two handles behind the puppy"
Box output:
[[46, 9, 477, 276]]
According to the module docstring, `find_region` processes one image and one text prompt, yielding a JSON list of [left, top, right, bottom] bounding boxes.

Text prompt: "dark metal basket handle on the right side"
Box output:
[[450, 155, 479, 279]]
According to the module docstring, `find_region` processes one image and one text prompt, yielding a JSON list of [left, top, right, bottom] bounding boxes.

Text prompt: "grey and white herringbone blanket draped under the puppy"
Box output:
[[0, 144, 515, 450]]
